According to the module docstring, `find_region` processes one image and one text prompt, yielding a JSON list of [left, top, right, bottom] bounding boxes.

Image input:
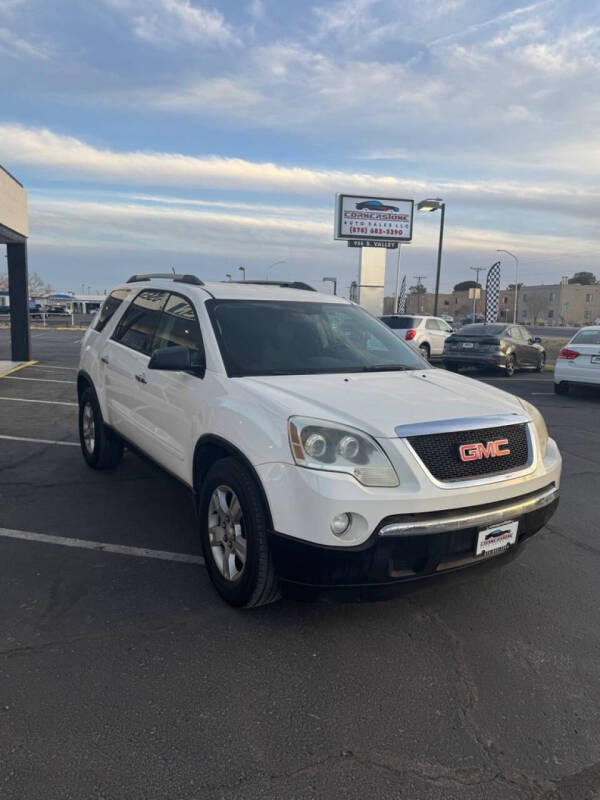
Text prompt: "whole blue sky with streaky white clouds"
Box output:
[[0, 0, 600, 293]]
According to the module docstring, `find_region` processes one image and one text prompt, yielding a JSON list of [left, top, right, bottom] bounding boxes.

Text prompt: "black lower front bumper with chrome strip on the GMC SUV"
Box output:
[[271, 484, 558, 588]]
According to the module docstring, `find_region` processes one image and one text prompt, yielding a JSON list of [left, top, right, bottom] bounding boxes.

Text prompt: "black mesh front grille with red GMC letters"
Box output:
[[408, 424, 529, 481]]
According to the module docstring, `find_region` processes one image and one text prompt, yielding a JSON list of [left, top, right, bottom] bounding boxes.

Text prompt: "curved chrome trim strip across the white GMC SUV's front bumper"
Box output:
[[379, 484, 559, 536]]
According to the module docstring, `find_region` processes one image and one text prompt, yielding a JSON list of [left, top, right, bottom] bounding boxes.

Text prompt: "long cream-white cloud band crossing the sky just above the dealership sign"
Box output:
[[0, 124, 600, 219]]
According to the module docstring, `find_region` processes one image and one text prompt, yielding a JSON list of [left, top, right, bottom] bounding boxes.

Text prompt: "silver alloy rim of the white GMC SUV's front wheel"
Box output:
[[208, 485, 248, 581]]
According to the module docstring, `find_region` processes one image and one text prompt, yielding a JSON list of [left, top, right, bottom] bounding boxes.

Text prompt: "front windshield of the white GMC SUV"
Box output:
[[206, 300, 427, 377]]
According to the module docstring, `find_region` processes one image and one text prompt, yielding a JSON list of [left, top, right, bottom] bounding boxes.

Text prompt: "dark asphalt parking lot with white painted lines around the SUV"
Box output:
[[0, 330, 600, 800]]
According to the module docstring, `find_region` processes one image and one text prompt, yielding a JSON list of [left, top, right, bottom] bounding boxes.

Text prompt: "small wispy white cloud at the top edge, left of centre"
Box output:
[[106, 0, 238, 47]]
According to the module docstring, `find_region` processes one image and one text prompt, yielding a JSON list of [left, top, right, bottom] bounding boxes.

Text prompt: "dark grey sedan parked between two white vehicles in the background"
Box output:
[[444, 323, 546, 377]]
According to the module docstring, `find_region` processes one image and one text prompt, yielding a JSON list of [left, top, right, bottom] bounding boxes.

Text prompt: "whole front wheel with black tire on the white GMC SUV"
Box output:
[[198, 458, 280, 608]]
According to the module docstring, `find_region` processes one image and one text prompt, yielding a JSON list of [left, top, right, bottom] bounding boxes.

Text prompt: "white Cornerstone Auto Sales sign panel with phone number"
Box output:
[[335, 194, 414, 247]]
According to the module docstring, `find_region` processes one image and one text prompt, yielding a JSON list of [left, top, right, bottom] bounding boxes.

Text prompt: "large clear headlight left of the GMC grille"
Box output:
[[288, 417, 399, 486]]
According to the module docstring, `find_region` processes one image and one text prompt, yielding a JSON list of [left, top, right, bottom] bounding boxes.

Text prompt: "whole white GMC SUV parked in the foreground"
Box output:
[[78, 275, 561, 606]]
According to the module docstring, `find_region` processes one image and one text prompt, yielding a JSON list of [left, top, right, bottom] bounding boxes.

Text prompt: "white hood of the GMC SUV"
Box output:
[[238, 369, 523, 438]]
